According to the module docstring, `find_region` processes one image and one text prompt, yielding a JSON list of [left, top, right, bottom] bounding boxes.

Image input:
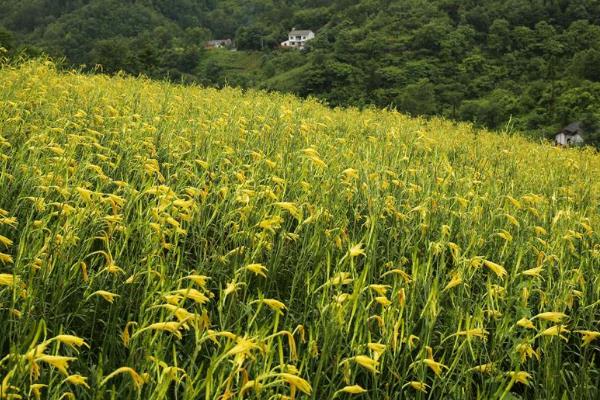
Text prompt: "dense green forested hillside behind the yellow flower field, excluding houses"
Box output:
[[0, 0, 600, 142]]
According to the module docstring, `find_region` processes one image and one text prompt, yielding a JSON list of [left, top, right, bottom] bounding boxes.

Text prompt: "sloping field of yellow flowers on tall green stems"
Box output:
[[0, 61, 600, 400]]
